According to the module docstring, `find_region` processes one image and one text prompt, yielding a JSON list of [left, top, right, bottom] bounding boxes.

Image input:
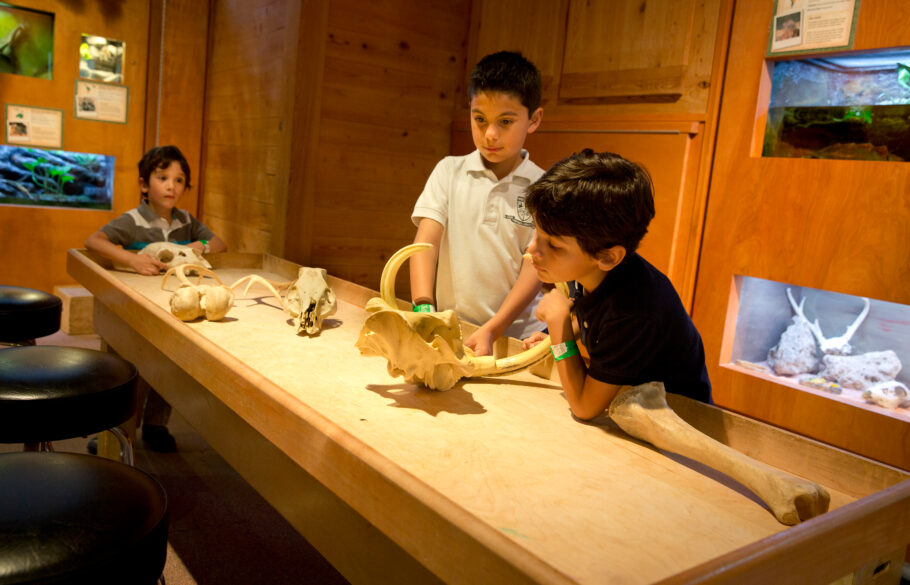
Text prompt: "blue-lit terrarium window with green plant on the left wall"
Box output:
[[0, 145, 115, 210]]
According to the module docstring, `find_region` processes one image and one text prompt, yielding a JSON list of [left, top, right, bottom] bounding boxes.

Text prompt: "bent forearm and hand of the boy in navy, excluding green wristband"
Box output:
[[537, 289, 621, 420]]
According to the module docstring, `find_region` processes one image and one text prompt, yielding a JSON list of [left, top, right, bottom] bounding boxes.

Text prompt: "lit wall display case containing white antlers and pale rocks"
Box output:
[[731, 276, 910, 421]]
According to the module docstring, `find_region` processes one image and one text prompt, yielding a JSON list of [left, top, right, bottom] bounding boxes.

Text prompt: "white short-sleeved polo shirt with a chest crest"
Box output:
[[411, 150, 545, 339]]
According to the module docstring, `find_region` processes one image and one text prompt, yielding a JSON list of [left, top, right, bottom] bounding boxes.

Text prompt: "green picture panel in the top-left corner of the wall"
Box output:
[[0, 2, 54, 79]]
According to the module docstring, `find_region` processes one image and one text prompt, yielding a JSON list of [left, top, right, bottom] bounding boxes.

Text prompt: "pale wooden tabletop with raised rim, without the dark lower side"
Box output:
[[69, 250, 910, 585]]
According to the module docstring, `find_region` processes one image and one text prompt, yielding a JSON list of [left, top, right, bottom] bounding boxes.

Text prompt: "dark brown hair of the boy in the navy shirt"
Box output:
[[525, 148, 654, 256]]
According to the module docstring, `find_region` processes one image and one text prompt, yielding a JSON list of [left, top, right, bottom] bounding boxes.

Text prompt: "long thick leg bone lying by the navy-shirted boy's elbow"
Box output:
[[609, 382, 830, 526]]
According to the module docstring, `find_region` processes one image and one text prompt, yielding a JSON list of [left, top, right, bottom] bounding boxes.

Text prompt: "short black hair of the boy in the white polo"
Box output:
[[468, 51, 541, 116]]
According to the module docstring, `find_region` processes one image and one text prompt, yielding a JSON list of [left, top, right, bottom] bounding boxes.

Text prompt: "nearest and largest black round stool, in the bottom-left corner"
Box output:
[[0, 452, 168, 585]]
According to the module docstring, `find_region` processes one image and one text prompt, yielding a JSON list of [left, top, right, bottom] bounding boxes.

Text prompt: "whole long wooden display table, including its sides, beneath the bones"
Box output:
[[67, 250, 910, 585]]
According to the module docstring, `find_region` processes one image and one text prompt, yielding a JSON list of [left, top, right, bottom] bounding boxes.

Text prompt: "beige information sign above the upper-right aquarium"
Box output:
[[768, 0, 860, 57]]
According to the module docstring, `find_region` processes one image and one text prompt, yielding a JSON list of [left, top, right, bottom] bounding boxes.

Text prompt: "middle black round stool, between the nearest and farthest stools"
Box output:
[[0, 345, 138, 465]]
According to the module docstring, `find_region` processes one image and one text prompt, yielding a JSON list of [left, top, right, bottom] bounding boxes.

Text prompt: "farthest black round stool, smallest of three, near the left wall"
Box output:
[[0, 286, 63, 345]]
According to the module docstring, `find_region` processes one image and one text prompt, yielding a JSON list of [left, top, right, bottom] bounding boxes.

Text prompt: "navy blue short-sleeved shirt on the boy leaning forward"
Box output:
[[574, 254, 711, 404]]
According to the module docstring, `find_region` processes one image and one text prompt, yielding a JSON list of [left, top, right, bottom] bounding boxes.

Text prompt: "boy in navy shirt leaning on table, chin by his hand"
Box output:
[[526, 149, 711, 419]]
